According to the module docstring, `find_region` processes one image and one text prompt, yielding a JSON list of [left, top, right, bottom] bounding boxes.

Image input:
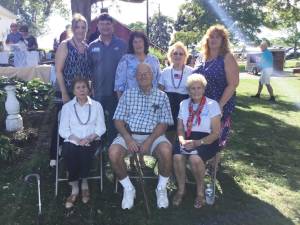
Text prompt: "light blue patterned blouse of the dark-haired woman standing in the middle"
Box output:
[[114, 54, 160, 92]]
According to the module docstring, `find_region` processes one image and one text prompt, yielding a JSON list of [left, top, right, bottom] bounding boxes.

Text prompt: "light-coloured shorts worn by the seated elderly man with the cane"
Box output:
[[112, 134, 171, 155]]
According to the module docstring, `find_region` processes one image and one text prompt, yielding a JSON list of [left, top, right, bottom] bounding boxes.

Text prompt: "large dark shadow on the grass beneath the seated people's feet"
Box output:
[[0, 152, 294, 225]]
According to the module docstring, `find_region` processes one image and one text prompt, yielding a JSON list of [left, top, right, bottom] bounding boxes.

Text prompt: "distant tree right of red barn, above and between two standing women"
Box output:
[[149, 13, 174, 50]]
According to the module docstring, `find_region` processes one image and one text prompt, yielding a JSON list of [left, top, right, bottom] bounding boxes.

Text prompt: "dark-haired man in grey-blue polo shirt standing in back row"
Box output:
[[88, 13, 127, 144]]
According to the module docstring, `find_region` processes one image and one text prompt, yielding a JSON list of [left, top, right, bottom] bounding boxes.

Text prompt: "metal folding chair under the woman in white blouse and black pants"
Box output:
[[55, 112, 103, 197]]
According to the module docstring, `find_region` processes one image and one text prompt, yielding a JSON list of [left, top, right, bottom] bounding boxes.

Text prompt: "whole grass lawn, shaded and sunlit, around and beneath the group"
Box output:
[[0, 77, 300, 225]]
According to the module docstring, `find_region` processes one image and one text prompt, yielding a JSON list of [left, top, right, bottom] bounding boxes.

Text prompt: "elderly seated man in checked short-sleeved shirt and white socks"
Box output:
[[109, 63, 173, 209]]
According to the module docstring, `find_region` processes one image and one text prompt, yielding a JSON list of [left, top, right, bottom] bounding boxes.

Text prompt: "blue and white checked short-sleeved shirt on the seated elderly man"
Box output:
[[113, 87, 173, 133]]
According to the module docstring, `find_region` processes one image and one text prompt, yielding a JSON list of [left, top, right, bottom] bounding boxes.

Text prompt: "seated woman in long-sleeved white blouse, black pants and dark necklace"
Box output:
[[59, 77, 106, 208]]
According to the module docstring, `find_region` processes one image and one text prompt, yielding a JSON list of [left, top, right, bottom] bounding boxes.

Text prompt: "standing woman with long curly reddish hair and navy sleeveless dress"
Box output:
[[194, 25, 239, 148]]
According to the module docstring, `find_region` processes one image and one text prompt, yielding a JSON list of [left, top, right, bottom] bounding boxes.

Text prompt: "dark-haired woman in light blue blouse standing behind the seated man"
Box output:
[[115, 31, 160, 98]]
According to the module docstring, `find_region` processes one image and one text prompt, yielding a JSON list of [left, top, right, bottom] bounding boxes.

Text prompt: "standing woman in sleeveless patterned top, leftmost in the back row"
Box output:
[[50, 14, 91, 166]]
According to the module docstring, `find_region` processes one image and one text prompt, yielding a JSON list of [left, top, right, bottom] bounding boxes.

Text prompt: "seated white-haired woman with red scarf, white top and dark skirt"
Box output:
[[173, 74, 221, 208]]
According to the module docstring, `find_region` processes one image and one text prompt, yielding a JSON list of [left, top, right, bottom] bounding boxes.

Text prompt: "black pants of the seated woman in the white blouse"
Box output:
[[63, 142, 97, 182]]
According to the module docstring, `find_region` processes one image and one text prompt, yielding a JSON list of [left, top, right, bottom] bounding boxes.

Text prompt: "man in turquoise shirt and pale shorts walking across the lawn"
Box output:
[[251, 41, 275, 102]]
